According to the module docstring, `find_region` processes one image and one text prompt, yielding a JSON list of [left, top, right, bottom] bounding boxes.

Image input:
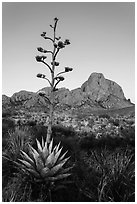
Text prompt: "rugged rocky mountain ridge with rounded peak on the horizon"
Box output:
[[2, 73, 134, 112]]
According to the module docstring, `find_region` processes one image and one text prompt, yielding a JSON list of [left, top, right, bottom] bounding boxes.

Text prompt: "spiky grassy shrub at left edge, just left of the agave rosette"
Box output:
[[2, 127, 32, 186]]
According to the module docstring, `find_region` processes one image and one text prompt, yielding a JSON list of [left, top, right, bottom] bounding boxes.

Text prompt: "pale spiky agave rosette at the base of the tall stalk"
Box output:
[[18, 138, 72, 182]]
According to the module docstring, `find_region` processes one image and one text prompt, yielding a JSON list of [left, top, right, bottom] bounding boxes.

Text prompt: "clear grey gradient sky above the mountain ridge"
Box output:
[[2, 2, 135, 102]]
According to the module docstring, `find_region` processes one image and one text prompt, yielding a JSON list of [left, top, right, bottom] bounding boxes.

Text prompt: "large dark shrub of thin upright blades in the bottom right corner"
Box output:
[[75, 149, 135, 202]]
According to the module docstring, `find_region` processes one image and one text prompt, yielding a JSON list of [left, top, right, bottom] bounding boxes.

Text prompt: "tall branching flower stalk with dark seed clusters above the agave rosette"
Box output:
[[36, 18, 73, 144]]
